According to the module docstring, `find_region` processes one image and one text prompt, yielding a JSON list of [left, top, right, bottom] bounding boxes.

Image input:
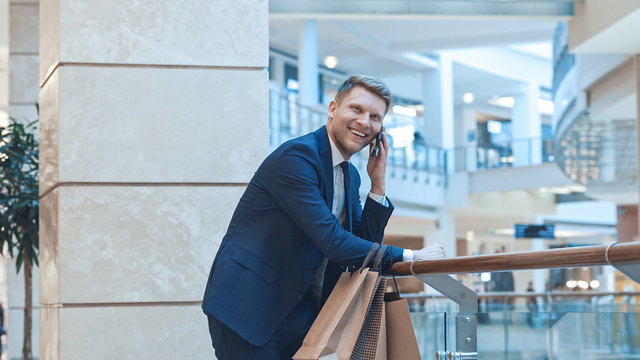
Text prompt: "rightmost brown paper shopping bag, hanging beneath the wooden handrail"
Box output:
[[384, 290, 420, 360]]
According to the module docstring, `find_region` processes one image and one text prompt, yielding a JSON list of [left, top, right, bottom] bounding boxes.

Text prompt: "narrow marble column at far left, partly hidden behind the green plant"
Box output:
[[6, 0, 40, 359]]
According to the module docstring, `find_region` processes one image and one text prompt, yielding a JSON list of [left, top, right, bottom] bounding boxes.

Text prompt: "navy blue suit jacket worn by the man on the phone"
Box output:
[[202, 126, 403, 346]]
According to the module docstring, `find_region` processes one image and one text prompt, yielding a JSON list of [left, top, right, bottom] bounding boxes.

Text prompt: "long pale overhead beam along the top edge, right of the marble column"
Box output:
[[269, 0, 574, 20]]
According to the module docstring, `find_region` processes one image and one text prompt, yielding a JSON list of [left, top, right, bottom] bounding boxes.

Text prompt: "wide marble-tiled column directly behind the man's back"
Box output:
[[40, 0, 269, 360]]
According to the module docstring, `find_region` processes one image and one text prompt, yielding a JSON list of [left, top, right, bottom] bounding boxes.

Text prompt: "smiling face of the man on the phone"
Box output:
[[327, 86, 386, 160]]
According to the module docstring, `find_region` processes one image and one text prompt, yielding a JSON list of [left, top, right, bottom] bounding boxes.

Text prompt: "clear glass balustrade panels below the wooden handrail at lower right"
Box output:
[[410, 299, 640, 360]]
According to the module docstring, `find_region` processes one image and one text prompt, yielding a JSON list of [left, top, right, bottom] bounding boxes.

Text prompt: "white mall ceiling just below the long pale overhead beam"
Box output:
[[269, 17, 557, 101]]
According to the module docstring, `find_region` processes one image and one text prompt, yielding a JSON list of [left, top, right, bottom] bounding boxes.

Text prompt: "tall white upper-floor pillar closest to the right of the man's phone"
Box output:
[[422, 55, 455, 172]]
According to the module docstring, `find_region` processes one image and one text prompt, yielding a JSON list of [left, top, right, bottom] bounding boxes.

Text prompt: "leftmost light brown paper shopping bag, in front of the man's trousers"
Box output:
[[293, 243, 382, 360]]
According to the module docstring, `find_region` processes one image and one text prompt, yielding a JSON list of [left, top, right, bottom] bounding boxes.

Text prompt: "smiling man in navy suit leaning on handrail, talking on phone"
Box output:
[[202, 76, 444, 360]]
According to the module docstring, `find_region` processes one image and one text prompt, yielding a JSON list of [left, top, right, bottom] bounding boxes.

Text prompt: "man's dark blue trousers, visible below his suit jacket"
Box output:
[[207, 292, 317, 360]]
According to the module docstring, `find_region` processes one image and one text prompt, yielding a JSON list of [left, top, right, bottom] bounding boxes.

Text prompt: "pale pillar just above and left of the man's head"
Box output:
[[298, 20, 319, 106]]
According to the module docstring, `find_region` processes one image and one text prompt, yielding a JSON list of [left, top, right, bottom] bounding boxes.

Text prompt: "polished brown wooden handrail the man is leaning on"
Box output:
[[391, 242, 640, 276]]
